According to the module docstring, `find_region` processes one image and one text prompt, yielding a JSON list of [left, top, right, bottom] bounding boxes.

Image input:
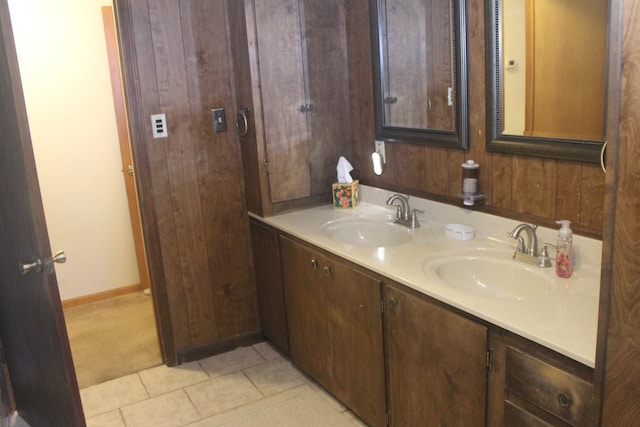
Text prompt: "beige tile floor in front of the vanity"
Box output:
[[80, 342, 364, 427]]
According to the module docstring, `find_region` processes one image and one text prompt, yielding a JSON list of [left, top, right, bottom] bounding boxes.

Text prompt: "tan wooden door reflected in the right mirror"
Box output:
[[526, 0, 607, 140]]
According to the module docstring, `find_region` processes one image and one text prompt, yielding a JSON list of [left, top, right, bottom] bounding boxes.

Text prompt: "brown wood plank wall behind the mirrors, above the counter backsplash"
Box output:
[[348, 0, 604, 237]]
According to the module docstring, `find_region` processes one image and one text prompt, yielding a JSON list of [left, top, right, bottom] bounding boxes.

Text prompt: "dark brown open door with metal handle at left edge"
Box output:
[[0, 0, 85, 427]]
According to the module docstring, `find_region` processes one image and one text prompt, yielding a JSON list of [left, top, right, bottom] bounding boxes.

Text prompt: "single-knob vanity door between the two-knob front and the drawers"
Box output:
[[385, 285, 487, 426]]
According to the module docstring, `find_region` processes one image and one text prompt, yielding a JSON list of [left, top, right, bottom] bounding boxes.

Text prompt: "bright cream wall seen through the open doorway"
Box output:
[[9, 0, 140, 300]]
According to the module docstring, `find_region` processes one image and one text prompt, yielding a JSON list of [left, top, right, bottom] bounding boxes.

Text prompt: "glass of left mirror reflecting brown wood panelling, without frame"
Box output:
[[379, 0, 455, 131]]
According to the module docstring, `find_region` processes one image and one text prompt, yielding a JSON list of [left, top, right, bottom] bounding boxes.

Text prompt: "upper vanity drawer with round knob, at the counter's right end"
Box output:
[[505, 347, 593, 425]]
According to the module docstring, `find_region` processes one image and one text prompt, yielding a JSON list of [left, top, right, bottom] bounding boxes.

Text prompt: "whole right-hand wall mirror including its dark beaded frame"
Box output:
[[485, 0, 608, 163]]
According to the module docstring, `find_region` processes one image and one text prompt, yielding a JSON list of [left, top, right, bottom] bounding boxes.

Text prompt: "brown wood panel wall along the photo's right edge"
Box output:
[[596, 0, 640, 426]]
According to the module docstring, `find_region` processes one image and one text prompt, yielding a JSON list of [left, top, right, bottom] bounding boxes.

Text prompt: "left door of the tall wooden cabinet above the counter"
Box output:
[[255, 0, 311, 203]]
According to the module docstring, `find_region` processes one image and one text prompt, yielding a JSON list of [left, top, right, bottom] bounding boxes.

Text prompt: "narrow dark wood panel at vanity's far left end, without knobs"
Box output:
[[251, 221, 289, 354]]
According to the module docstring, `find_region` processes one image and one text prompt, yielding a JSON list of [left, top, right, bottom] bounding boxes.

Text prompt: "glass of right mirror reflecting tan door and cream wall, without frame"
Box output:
[[498, 0, 607, 141]]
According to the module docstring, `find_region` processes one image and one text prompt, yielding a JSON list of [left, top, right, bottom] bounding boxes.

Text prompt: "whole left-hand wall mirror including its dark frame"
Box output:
[[370, 0, 468, 149]]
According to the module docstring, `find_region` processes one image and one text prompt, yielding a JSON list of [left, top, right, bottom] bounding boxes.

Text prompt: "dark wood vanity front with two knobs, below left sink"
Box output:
[[280, 237, 387, 426]]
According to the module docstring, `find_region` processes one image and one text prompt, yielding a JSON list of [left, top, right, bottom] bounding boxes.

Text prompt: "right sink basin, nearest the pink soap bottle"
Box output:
[[422, 248, 552, 300]]
